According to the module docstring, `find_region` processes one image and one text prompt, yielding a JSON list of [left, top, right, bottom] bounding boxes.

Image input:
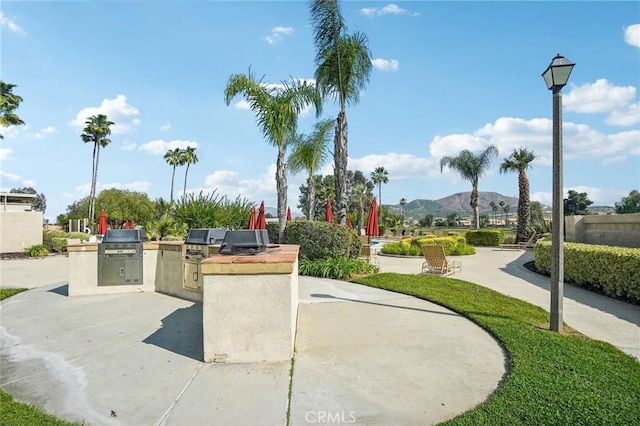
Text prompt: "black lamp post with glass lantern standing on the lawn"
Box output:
[[542, 54, 575, 333]]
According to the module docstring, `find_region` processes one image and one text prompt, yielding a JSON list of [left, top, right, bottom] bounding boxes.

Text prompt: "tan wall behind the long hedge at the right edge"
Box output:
[[564, 213, 640, 248]]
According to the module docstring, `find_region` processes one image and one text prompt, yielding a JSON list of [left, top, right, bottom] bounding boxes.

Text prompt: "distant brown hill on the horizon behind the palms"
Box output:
[[385, 191, 518, 220]]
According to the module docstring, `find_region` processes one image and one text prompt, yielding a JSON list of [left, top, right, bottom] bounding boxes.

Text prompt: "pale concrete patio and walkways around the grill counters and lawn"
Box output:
[[0, 248, 640, 425]]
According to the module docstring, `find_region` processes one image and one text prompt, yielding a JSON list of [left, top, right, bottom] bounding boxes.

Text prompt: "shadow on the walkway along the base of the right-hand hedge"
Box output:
[[501, 256, 640, 326]]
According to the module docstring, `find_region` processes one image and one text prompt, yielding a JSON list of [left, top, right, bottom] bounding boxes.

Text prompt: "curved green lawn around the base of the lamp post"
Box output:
[[354, 273, 640, 426]]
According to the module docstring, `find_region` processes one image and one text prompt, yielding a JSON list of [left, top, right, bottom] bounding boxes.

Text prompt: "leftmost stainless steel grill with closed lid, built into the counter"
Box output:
[[98, 229, 144, 286]]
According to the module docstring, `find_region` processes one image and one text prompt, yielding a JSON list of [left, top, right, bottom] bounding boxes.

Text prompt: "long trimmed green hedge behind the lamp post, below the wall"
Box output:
[[534, 239, 640, 304]]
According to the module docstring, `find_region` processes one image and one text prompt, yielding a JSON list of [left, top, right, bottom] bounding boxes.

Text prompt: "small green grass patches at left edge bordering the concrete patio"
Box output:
[[0, 288, 82, 426]]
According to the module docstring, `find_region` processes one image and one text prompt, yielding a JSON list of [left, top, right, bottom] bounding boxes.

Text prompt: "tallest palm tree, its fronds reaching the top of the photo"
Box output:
[[310, 0, 372, 225]]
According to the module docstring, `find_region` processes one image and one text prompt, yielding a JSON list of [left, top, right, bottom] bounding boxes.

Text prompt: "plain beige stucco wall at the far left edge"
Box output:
[[0, 211, 42, 253]]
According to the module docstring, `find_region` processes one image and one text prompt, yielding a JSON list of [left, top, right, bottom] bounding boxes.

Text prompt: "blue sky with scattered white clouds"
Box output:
[[0, 1, 640, 220]]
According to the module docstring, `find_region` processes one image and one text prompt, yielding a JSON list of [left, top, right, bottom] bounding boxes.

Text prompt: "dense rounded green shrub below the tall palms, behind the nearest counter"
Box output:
[[285, 220, 358, 260]]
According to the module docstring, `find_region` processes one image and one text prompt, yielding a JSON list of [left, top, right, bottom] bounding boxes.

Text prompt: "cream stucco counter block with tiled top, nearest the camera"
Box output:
[[202, 245, 299, 363]]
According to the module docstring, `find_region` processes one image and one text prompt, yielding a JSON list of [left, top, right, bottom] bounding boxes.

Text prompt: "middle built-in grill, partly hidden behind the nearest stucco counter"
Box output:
[[182, 228, 227, 291]]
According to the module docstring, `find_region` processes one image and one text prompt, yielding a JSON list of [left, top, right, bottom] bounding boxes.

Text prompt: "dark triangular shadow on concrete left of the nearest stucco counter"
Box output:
[[143, 303, 204, 361]]
